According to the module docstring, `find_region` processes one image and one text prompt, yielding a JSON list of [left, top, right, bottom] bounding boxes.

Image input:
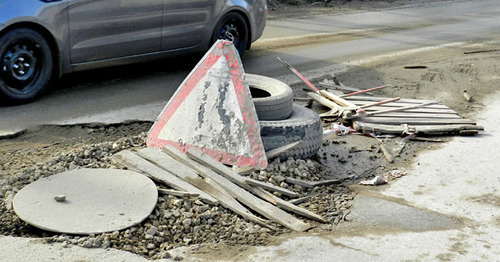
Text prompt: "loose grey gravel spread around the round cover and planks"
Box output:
[[0, 124, 354, 260]]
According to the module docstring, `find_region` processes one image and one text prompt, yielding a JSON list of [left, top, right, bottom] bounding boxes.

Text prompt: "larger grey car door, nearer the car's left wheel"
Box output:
[[68, 0, 164, 63]]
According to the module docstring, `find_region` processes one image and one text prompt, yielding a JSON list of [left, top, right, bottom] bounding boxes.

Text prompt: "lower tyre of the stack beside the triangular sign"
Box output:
[[259, 105, 323, 160]]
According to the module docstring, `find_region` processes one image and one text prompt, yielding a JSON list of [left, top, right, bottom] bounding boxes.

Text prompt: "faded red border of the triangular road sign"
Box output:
[[147, 41, 267, 169]]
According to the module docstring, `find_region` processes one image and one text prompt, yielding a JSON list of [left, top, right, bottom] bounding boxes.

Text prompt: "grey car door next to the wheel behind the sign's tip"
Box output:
[[162, 0, 217, 50]]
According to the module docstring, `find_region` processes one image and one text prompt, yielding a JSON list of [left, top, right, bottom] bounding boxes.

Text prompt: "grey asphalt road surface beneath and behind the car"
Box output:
[[0, 0, 500, 131]]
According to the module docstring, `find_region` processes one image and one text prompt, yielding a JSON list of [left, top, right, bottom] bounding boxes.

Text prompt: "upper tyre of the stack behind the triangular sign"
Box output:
[[245, 74, 293, 120]]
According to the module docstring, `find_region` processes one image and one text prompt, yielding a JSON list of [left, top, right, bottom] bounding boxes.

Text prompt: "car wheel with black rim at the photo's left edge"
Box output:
[[0, 28, 53, 104]]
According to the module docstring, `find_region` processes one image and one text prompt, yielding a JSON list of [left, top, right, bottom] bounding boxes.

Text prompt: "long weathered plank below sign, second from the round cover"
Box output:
[[139, 148, 267, 226]]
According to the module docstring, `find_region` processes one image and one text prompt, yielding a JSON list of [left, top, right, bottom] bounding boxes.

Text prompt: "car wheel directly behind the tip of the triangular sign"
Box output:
[[212, 13, 250, 56]]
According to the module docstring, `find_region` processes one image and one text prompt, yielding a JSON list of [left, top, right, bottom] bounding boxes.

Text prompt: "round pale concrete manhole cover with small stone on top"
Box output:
[[13, 169, 158, 234]]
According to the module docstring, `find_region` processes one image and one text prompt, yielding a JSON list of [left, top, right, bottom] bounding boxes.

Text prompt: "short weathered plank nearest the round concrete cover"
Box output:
[[112, 150, 219, 205]]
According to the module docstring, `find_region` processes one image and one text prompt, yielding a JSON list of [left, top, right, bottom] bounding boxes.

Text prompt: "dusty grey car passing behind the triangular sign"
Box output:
[[0, 0, 267, 106]]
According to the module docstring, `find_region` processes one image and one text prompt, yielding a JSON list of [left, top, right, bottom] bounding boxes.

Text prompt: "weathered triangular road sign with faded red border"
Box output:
[[147, 40, 267, 169]]
